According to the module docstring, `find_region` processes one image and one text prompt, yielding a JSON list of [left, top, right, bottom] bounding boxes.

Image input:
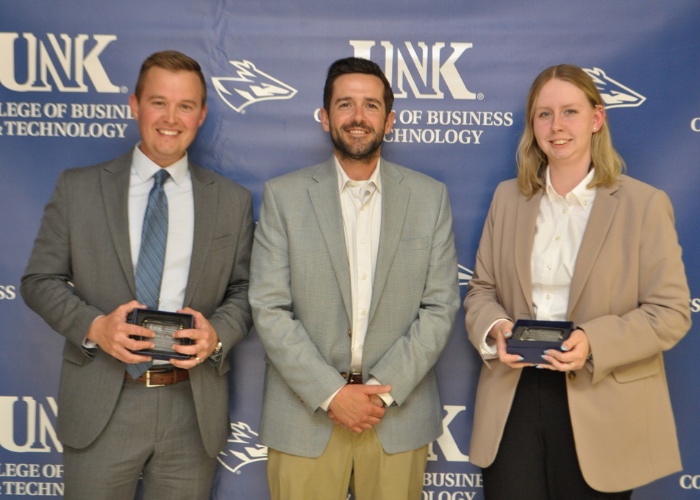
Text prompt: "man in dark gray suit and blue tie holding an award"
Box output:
[[21, 51, 253, 500]]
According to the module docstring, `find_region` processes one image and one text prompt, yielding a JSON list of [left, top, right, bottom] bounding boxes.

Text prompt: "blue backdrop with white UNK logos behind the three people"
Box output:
[[0, 0, 700, 500]]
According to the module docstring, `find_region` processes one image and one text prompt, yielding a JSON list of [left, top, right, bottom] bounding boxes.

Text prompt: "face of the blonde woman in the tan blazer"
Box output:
[[532, 78, 605, 170]]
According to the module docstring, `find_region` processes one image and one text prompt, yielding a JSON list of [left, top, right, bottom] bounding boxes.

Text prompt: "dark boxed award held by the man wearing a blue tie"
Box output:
[[127, 309, 194, 360]]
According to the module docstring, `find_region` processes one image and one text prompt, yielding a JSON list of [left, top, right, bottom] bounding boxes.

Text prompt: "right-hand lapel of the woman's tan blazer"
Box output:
[[567, 183, 619, 318]]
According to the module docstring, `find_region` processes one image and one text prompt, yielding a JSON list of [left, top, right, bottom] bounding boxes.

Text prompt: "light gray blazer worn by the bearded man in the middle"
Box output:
[[250, 158, 459, 457]]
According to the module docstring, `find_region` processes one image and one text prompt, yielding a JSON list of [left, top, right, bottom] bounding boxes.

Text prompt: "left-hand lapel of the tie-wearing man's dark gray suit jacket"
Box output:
[[100, 152, 136, 297]]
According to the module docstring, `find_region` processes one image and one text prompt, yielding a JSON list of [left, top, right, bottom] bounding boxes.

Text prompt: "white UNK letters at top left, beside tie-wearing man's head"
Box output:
[[0, 33, 121, 93]]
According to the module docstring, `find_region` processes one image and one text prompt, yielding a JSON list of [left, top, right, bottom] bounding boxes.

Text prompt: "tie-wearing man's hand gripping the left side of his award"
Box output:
[[87, 300, 155, 363]]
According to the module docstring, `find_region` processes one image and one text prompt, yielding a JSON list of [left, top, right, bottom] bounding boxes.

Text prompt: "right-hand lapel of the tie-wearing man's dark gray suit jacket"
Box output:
[[184, 163, 219, 307]]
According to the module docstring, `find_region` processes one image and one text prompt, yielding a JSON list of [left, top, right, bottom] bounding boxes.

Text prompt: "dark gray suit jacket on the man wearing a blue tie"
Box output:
[[21, 152, 253, 457]]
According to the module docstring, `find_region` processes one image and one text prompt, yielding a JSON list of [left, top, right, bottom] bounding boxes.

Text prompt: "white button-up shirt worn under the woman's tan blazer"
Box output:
[[480, 167, 596, 359]]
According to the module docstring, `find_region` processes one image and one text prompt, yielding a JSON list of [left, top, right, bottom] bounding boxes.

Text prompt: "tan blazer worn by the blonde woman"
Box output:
[[464, 176, 690, 491]]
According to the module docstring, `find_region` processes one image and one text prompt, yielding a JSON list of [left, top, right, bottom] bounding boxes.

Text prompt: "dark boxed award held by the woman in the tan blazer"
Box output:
[[506, 319, 574, 363]]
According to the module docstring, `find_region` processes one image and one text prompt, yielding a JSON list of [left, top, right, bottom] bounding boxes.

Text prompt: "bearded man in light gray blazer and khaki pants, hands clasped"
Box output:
[[250, 58, 459, 500]]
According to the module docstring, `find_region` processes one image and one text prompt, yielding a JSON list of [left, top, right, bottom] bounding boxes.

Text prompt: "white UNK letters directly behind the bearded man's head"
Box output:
[[350, 40, 484, 100]]
